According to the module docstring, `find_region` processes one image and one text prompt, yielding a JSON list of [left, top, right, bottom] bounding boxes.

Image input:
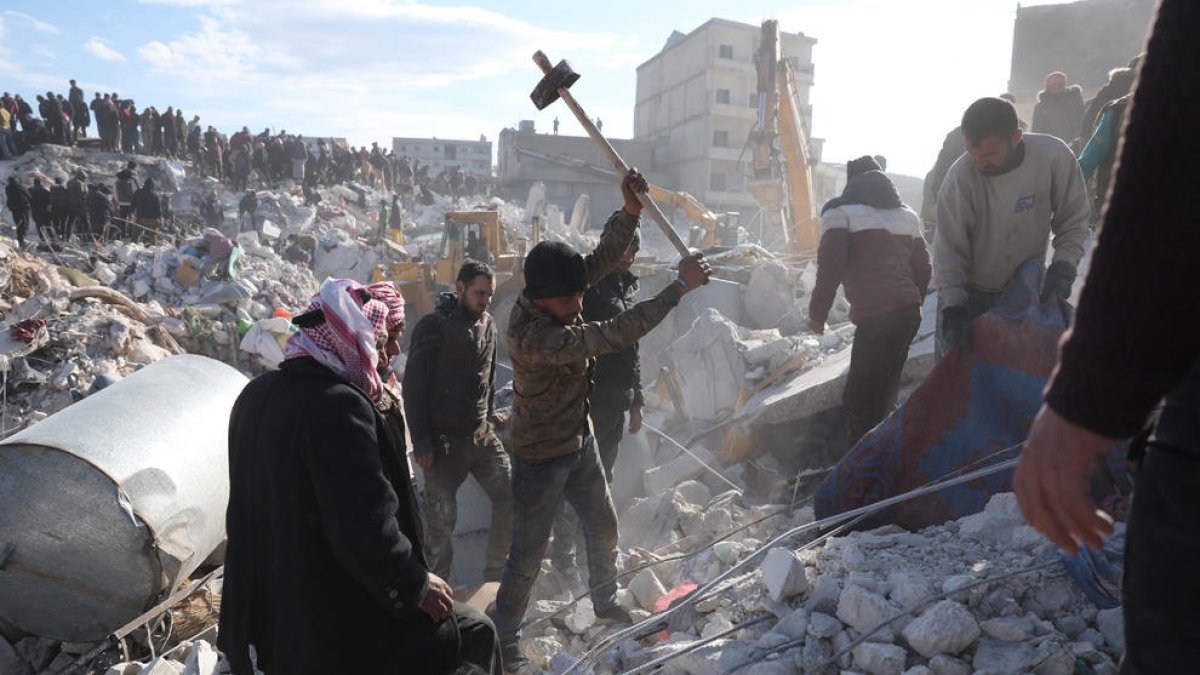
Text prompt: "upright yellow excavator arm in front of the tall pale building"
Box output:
[[750, 19, 821, 258]]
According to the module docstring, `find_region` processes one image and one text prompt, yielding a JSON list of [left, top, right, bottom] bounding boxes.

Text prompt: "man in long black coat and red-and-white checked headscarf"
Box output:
[[218, 280, 500, 675]]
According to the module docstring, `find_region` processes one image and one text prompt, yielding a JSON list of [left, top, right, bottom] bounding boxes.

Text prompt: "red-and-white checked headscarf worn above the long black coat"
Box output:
[[284, 279, 391, 404]]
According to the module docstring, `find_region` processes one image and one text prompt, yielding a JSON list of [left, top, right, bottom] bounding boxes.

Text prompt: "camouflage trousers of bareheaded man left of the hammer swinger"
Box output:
[[421, 432, 512, 581]]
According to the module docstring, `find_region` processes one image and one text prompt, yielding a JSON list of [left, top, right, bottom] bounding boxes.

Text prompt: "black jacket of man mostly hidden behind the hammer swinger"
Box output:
[[583, 266, 643, 410]]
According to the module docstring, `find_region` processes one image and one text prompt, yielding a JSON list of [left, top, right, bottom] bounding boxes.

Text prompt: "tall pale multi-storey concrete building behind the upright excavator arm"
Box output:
[[634, 18, 821, 226]]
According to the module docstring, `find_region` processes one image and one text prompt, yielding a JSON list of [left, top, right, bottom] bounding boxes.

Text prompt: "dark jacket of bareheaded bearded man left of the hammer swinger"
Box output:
[[404, 293, 496, 453]]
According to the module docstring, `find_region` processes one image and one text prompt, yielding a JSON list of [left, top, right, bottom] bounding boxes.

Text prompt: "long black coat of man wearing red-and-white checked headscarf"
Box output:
[[218, 357, 452, 675]]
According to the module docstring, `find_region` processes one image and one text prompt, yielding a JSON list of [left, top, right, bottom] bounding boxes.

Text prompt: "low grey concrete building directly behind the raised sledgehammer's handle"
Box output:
[[497, 120, 661, 227]]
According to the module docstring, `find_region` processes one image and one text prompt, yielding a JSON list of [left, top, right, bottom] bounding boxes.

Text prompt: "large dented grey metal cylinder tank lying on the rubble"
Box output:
[[0, 354, 247, 641]]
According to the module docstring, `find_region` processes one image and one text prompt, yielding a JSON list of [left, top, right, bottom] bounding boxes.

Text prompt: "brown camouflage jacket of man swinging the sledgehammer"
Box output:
[[508, 210, 679, 460]]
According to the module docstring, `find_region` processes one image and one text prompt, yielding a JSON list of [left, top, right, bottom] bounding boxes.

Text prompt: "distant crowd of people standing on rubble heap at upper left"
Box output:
[[0, 79, 488, 245]]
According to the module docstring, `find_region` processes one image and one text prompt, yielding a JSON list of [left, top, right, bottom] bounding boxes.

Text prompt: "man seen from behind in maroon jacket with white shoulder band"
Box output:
[[809, 156, 932, 442]]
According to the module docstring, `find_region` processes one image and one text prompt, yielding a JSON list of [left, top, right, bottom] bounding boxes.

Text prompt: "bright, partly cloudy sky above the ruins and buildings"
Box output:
[[0, 0, 1084, 175]]
